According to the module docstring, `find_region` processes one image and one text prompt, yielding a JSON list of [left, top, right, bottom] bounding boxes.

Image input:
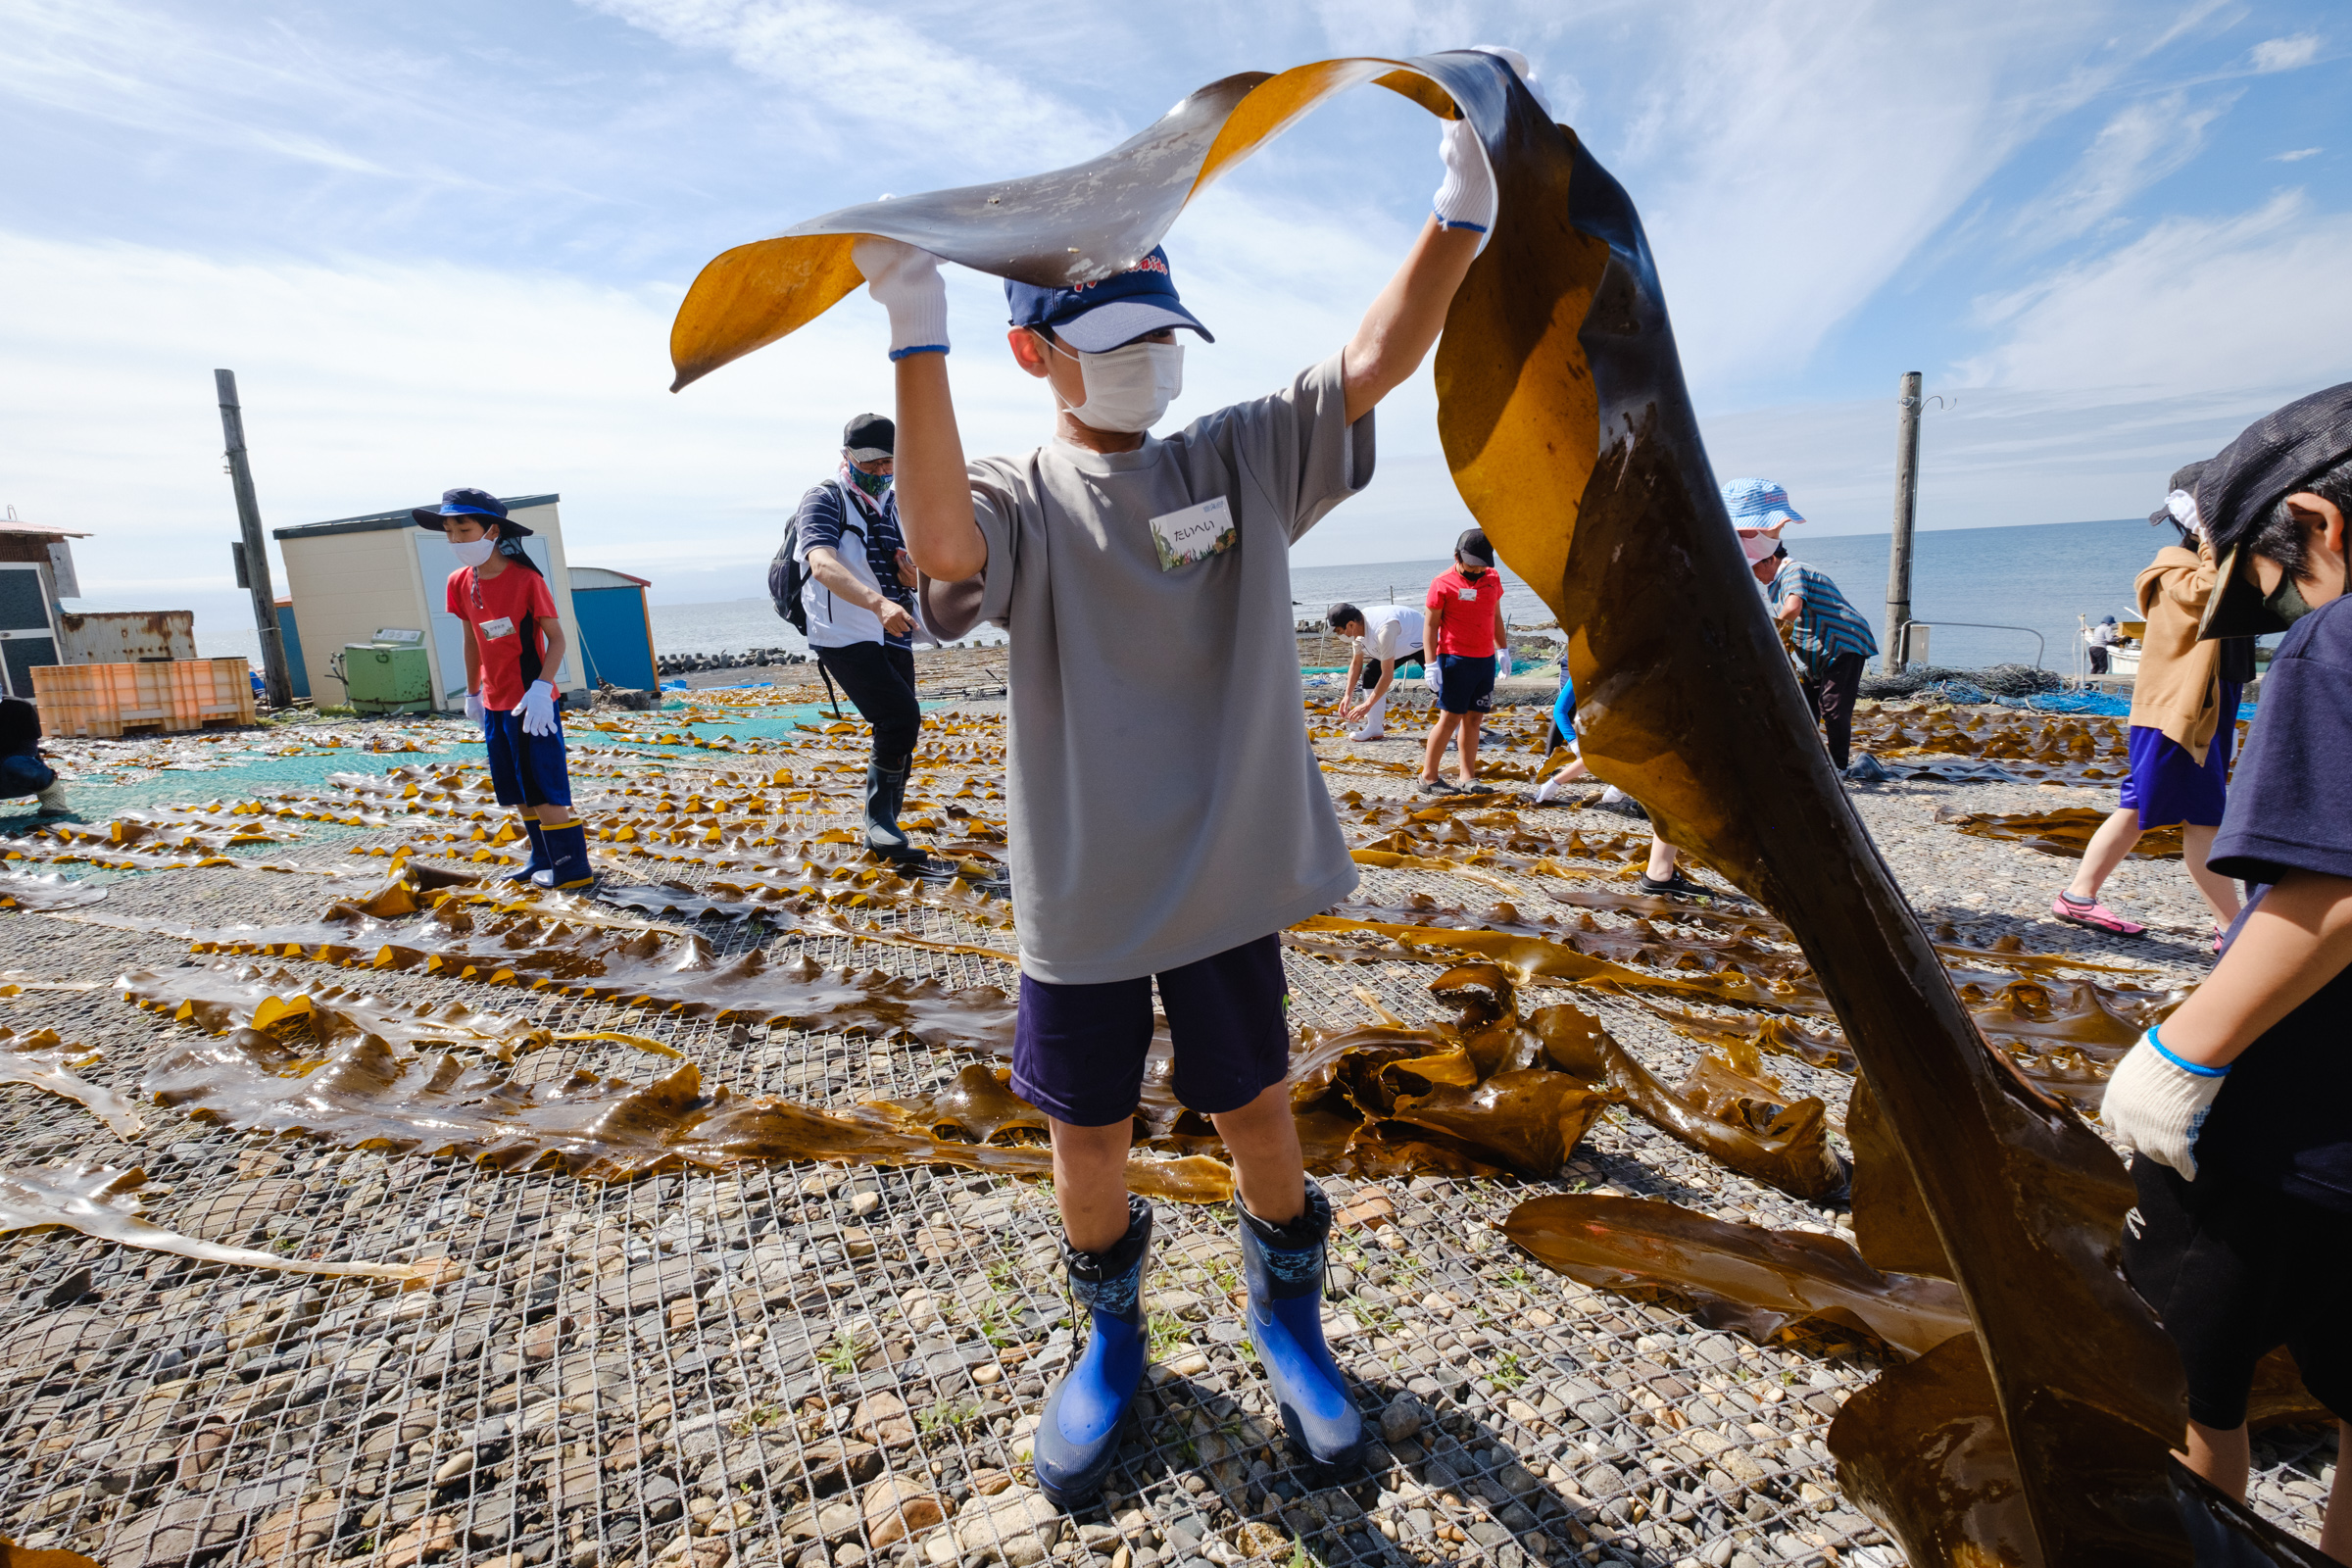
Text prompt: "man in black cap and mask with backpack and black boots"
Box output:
[[793, 414, 924, 860]]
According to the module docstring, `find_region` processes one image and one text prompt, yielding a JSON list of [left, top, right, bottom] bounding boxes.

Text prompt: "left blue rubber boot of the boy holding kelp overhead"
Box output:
[[1030, 1195, 1152, 1511]]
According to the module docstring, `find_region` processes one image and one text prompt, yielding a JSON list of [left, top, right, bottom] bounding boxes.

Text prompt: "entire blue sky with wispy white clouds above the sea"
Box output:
[[0, 0, 2352, 634]]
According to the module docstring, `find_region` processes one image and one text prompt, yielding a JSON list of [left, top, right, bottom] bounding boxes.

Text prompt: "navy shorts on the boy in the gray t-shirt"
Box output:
[[1013, 936, 1292, 1126]]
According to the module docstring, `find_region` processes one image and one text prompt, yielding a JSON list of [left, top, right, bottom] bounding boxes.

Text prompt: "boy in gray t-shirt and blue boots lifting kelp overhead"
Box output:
[[854, 61, 1517, 1507]]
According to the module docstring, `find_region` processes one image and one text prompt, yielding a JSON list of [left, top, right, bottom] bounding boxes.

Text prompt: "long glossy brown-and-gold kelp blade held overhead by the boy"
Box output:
[[672, 52, 2189, 1566]]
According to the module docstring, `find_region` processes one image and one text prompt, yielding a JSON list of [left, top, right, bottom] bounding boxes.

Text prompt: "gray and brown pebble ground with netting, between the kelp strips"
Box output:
[[0, 696, 2333, 1568]]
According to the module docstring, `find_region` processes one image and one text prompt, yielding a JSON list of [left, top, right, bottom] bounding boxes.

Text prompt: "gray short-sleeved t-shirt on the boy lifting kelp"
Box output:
[[971, 355, 1374, 985]]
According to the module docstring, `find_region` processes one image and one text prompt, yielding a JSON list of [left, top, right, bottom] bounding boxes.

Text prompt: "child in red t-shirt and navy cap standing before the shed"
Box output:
[[410, 489, 595, 889]]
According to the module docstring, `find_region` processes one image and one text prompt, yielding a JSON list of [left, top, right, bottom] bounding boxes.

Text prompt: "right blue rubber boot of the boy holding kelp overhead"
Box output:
[[1233, 1178, 1364, 1469]]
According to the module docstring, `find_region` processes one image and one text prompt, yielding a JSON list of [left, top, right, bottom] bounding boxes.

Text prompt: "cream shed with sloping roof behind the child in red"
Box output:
[[272, 496, 588, 710]]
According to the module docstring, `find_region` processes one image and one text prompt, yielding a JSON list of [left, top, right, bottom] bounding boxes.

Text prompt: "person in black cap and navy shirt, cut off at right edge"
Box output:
[[2100, 383, 2352, 1563]]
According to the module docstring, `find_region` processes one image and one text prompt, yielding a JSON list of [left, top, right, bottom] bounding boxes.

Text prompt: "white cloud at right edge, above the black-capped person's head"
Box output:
[[1957, 190, 2352, 395]]
